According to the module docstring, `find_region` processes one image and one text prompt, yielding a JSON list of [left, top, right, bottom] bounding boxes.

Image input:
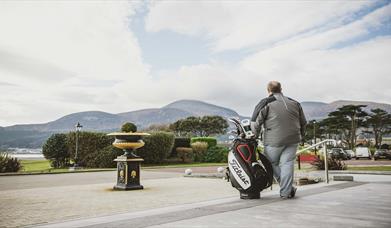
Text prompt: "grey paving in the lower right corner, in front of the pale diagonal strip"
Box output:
[[148, 183, 391, 228]]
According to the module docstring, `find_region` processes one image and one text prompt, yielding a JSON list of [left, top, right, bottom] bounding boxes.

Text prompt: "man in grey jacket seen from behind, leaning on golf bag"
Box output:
[[251, 81, 306, 199]]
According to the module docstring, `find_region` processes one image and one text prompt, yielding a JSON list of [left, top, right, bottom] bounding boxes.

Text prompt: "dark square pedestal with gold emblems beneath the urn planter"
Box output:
[[113, 155, 144, 190]]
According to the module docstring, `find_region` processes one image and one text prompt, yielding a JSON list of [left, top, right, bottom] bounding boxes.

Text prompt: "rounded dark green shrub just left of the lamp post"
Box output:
[[42, 133, 69, 168]]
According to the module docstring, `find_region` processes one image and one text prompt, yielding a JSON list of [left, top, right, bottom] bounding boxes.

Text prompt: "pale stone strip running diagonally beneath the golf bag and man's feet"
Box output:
[[33, 182, 368, 228]]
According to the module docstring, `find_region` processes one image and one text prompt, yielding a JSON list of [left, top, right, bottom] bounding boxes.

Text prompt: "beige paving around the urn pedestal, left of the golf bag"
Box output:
[[0, 172, 237, 227]]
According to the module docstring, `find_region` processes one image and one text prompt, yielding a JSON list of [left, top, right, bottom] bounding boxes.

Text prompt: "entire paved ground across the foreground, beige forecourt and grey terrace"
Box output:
[[0, 167, 391, 227]]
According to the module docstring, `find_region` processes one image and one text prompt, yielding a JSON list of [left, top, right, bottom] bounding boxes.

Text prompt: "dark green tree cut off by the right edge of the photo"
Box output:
[[367, 108, 391, 148]]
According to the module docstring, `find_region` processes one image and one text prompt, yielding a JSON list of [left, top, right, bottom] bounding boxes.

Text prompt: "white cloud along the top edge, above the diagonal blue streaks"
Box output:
[[146, 1, 374, 51]]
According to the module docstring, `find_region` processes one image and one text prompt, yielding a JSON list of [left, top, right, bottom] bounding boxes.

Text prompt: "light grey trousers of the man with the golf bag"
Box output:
[[265, 144, 298, 197]]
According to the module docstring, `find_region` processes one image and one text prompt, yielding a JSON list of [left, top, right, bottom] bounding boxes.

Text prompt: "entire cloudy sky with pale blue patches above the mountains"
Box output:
[[0, 0, 391, 126]]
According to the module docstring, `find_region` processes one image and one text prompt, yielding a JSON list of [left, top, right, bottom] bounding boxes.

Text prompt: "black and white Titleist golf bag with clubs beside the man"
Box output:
[[227, 119, 273, 199]]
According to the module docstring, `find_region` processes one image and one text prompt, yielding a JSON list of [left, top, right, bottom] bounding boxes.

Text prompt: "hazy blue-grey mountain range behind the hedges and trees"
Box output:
[[0, 100, 391, 148]]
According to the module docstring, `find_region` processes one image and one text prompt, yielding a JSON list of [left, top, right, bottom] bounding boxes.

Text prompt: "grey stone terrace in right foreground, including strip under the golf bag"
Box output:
[[36, 182, 391, 228]]
